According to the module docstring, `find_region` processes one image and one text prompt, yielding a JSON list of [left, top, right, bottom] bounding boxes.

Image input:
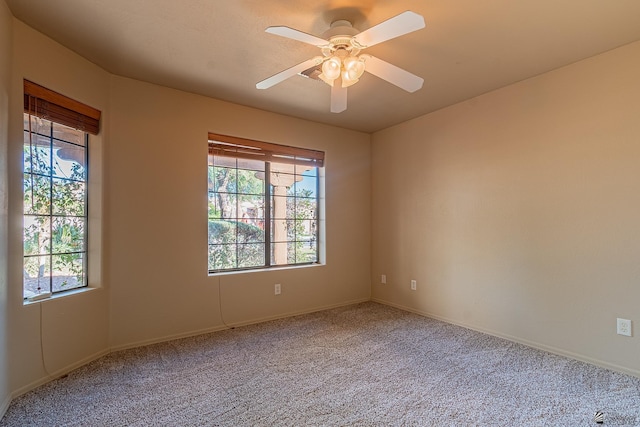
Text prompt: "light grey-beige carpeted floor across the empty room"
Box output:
[[0, 303, 640, 426]]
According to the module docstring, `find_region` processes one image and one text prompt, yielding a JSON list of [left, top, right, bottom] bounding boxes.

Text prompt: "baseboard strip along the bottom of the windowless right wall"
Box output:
[[371, 298, 640, 378]]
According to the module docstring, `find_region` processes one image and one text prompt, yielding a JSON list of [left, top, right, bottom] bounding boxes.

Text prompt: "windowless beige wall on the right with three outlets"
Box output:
[[372, 42, 640, 375]]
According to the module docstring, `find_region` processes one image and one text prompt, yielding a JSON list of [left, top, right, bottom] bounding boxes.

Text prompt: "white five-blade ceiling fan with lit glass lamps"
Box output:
[[256, 11, 425, 113]]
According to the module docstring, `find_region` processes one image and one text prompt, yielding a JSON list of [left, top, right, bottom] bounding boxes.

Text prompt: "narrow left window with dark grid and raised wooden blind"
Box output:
[[23, 80, 100, 300]]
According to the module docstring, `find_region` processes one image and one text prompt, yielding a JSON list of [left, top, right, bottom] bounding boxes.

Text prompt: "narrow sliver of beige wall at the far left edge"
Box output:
[[0, 0, 13, 417]]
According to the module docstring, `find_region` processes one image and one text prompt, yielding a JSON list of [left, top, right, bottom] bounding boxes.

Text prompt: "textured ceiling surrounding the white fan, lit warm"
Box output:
[[7, 0, 640, 132]]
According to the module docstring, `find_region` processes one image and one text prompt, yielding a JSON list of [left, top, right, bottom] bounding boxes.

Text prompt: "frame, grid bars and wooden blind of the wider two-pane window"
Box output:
[[207, 133, 324, 274]]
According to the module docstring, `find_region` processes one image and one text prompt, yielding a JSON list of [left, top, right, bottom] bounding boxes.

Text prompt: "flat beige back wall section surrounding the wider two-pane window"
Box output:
[[105, 76, 370, 348]]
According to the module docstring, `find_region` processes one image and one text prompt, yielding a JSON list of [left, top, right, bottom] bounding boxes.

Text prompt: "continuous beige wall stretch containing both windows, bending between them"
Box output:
[[5, 15, 371, 402]]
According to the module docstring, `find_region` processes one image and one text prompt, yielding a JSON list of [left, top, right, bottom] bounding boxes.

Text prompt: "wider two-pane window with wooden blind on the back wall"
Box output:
[[208, 134, 324, 273]]
